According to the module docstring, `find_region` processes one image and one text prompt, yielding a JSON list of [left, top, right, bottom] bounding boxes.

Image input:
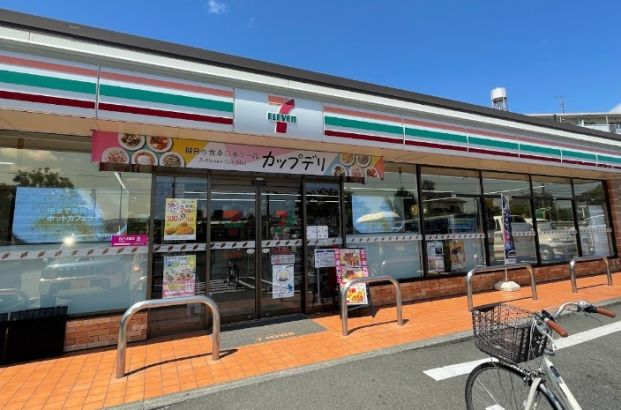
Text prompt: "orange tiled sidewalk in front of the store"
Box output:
[[0, 273, 621, 409]]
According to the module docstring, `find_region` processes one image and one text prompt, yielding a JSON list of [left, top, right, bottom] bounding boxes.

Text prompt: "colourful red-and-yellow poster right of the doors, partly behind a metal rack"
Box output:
[[334, 249, 369, 305]]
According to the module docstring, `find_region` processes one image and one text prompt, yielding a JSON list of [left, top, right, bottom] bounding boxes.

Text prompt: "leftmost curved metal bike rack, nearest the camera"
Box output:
[[116, 295, 220, 379]]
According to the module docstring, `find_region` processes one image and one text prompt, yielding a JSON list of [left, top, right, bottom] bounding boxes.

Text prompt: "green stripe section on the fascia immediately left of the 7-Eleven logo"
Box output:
[[99, 84, 233, 113]]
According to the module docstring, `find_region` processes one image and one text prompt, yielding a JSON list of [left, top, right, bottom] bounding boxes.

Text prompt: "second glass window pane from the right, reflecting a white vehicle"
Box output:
[[533, 198, 578, 263]]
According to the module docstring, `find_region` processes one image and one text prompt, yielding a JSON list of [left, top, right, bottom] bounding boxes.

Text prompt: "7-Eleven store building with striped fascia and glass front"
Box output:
[[0, 11, 621, 350]]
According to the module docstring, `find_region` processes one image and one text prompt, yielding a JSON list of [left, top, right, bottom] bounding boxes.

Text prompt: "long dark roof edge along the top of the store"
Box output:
[[0, 9, 621, 141]]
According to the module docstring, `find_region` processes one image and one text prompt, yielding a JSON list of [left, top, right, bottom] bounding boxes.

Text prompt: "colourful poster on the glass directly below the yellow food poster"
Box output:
[[162, 255, 196, 298]]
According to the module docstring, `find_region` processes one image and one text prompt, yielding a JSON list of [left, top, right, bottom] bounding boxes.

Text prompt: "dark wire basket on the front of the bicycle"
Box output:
[[472, 305, 548, 364]]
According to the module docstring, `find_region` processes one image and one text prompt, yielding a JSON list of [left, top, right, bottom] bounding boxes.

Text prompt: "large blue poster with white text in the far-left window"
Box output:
[[12, 187, 111, 243]]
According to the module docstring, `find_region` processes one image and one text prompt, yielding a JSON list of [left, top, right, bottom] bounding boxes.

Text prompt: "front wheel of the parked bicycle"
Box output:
[[466, 362, 556, 410]]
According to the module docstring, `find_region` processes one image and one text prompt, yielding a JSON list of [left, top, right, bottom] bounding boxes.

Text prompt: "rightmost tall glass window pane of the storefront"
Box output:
[[573, 179, 614, 256]]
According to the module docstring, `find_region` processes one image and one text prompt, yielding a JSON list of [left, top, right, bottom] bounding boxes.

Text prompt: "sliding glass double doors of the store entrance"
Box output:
[[207, 178, 304, 321]]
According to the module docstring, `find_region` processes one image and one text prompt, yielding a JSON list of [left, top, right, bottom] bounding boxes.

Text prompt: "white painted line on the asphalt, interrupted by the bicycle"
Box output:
[[423, 322, 621, 381]]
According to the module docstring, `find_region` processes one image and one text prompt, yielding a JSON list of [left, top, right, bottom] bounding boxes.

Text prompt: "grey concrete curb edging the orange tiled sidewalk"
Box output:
[[112, 297, 621, 410]]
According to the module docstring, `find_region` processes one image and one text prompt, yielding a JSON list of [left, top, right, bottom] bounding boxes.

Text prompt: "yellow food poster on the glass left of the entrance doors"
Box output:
[[164, 198, 198, 241]]
